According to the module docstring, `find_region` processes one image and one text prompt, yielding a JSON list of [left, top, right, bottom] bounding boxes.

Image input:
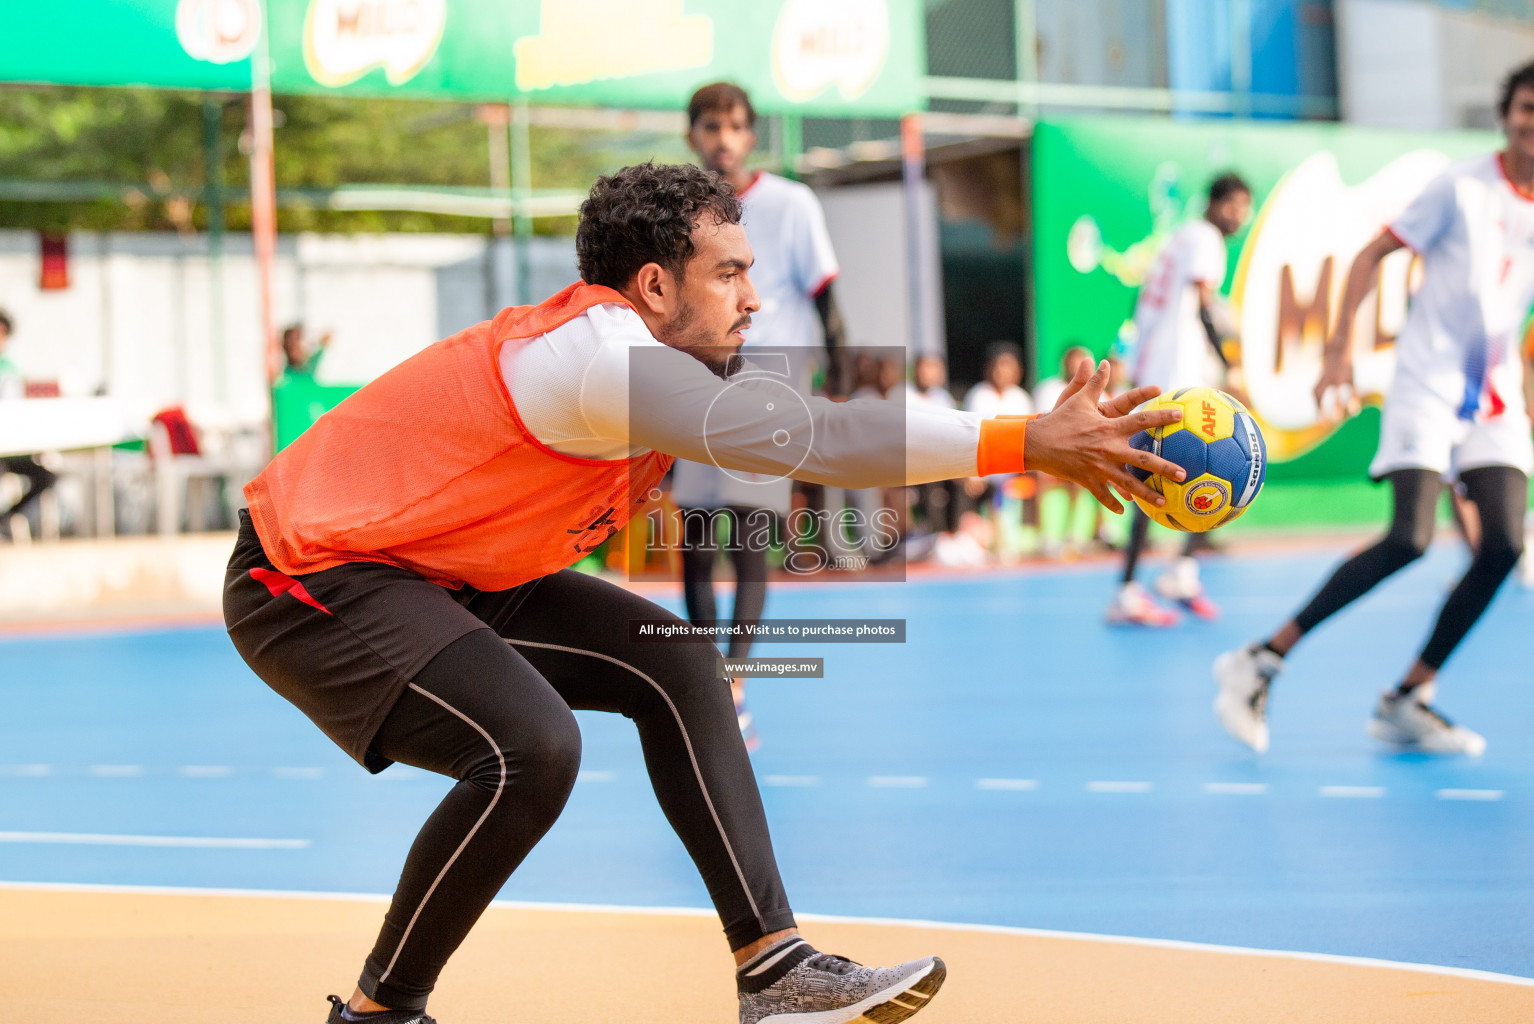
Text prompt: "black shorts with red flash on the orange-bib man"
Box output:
[[224, 510, 538, 773]]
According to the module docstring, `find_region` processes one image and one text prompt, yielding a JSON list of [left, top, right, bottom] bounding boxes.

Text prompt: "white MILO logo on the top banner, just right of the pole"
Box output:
[[304, 0, 448, 87]]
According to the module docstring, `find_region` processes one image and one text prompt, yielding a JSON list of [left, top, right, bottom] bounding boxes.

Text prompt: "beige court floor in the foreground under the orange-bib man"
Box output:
[[0, 889, 1534, 1024]]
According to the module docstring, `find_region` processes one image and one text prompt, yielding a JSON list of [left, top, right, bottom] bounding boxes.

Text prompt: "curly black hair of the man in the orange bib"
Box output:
[[575, 162, 741, 288]]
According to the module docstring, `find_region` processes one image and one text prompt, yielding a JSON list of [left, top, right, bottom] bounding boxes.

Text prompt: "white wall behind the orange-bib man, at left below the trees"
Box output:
[[0, 231, 577, 422]]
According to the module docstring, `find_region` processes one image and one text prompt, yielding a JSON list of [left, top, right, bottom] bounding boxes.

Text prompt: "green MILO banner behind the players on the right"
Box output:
[[1032, 118, 1502, 478]]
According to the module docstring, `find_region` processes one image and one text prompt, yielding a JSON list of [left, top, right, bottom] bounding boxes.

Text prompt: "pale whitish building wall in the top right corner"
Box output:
[[1336, 0, 1534, 130]]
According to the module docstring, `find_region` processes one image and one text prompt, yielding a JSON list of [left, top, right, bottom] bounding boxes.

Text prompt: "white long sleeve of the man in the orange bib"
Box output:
[[500, 304, 985, 484]]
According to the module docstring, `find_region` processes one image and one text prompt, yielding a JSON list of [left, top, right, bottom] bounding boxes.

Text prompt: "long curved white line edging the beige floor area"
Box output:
[[0, 881, 1534, 989]]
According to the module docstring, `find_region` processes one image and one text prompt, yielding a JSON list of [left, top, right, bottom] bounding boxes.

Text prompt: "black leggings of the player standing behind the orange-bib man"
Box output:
[[681, 506, 778, 658]]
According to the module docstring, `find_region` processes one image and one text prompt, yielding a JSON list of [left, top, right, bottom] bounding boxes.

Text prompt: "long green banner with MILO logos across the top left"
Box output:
[[0, 0, 925, 117]]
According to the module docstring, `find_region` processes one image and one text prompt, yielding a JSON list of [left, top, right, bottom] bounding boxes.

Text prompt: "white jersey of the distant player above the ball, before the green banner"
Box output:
[[1134, 218, 1226, 391]]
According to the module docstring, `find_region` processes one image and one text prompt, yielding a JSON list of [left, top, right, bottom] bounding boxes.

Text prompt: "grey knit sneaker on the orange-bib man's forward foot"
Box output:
[[741, 943, 948, 1024]]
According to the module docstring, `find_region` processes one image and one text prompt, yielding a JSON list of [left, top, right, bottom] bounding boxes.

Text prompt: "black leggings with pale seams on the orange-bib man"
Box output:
[[359, 572, 793, 1009]]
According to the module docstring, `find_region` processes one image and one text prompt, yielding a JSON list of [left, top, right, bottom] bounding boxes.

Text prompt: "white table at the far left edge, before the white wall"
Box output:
[[0, 397, 147, 537]]
